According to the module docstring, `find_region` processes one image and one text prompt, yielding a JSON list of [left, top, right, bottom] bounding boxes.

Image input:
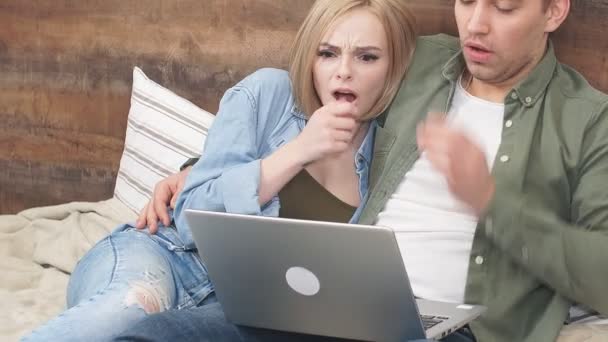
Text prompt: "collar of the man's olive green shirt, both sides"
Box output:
[[442, 40, 557, 107]]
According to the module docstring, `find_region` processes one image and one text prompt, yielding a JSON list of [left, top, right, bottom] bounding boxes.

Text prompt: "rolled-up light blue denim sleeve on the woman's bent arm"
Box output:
[[174, 85, 261, 243]]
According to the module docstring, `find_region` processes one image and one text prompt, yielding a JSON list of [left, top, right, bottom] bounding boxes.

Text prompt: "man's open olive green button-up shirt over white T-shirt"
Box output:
[[360, 35, 608, 342]]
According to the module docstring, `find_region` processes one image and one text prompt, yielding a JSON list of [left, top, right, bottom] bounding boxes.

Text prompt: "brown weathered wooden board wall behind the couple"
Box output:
[[0, 0, 608, 214]]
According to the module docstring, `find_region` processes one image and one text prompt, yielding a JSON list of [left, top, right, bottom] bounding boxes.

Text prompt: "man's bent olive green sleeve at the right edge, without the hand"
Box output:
[[487, 104, 608, 314]]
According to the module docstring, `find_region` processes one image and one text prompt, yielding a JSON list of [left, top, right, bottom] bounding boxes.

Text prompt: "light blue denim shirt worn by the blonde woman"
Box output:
[[174, 69, 376, 247]]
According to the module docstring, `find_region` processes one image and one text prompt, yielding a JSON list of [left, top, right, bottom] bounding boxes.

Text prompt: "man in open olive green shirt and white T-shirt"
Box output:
[[126, 0, 608, 342]]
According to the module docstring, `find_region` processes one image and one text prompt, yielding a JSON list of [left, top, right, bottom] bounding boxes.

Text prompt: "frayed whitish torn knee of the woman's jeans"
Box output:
[[124, 281, 168, 314]]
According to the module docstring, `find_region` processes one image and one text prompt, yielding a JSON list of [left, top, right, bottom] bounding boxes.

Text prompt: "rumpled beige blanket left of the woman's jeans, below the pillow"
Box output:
[[0, 199, 136, 341]]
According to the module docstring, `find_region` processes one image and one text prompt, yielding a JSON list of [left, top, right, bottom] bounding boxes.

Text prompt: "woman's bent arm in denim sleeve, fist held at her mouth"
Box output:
[[175, 69, 358, 226]]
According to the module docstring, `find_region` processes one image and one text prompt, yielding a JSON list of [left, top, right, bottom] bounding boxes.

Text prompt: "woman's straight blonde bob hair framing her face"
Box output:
[[289, 0, 416, 120]]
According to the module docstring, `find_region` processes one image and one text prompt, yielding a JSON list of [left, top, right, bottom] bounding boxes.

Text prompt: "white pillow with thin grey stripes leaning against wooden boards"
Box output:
[[114, 67, 214, 213]]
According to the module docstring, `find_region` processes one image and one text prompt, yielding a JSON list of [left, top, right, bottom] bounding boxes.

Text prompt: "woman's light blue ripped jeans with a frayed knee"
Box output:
[[23, 225, 214, 341]]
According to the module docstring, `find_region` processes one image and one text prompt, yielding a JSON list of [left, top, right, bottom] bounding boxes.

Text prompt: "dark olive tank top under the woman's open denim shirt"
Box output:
[[279, 170, 357, 223]]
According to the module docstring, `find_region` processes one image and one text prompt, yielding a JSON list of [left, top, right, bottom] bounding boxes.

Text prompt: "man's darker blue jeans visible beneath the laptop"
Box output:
[[114, 295, 475, 342]]
